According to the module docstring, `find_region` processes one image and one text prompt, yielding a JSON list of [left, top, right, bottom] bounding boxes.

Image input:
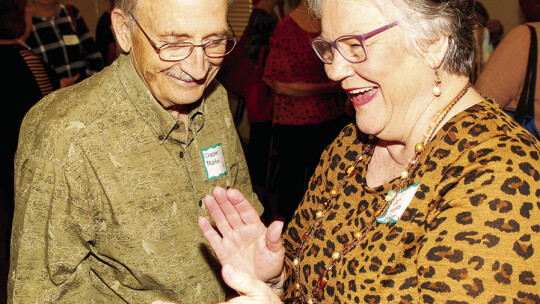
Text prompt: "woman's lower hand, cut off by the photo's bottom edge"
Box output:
[[217, 264, 282, 304]]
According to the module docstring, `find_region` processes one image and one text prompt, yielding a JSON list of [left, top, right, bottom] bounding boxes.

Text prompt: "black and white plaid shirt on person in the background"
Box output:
[[26, 4, 103, 81]]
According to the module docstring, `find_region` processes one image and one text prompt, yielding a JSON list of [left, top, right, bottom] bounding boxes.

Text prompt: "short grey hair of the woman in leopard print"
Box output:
[[307, 0, 476, 76]]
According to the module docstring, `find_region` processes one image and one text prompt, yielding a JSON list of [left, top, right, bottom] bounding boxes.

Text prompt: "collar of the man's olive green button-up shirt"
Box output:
[[117, 55, 210, 143]]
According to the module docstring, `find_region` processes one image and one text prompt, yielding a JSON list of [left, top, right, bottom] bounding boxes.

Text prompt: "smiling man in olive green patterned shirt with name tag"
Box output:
[[8, 0, 262, 303]]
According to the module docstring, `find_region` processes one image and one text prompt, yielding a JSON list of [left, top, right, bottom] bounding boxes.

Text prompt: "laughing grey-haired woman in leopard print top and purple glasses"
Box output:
[[199, 0, 540, 303]]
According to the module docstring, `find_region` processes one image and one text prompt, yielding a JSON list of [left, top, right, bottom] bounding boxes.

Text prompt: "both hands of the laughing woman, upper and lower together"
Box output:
[[199, 187, 285, 304]]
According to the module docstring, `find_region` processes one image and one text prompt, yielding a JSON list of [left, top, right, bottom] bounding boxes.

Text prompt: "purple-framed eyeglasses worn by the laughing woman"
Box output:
[[311, 22, 397, 64]]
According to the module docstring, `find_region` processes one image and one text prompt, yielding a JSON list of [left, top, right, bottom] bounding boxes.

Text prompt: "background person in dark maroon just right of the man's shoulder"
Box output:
[[216, 0, 280, 218]]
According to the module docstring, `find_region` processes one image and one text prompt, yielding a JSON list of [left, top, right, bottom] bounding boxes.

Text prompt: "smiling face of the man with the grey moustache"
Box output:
[[129, 0, 230, 109]]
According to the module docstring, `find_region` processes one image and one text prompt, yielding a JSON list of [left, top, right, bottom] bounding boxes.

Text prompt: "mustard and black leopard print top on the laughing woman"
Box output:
[[281, 100, 540, 303]]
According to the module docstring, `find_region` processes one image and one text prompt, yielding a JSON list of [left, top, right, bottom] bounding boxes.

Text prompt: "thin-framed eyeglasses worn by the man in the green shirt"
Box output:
[[131, 15, 238, 61]]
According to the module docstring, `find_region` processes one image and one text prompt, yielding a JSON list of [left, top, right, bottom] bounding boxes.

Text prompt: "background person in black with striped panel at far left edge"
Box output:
[[0, 0, 60, 303]]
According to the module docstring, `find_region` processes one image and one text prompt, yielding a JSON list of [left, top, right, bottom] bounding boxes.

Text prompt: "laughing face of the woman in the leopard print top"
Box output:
[[321, 0, 434, 141]]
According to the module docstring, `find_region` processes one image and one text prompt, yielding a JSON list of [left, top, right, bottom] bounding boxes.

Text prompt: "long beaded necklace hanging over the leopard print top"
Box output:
[[288, 82, 472, 304]]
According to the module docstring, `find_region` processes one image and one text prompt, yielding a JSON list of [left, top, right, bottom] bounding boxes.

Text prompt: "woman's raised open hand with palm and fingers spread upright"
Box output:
[[199, 187, 285, 284]]
